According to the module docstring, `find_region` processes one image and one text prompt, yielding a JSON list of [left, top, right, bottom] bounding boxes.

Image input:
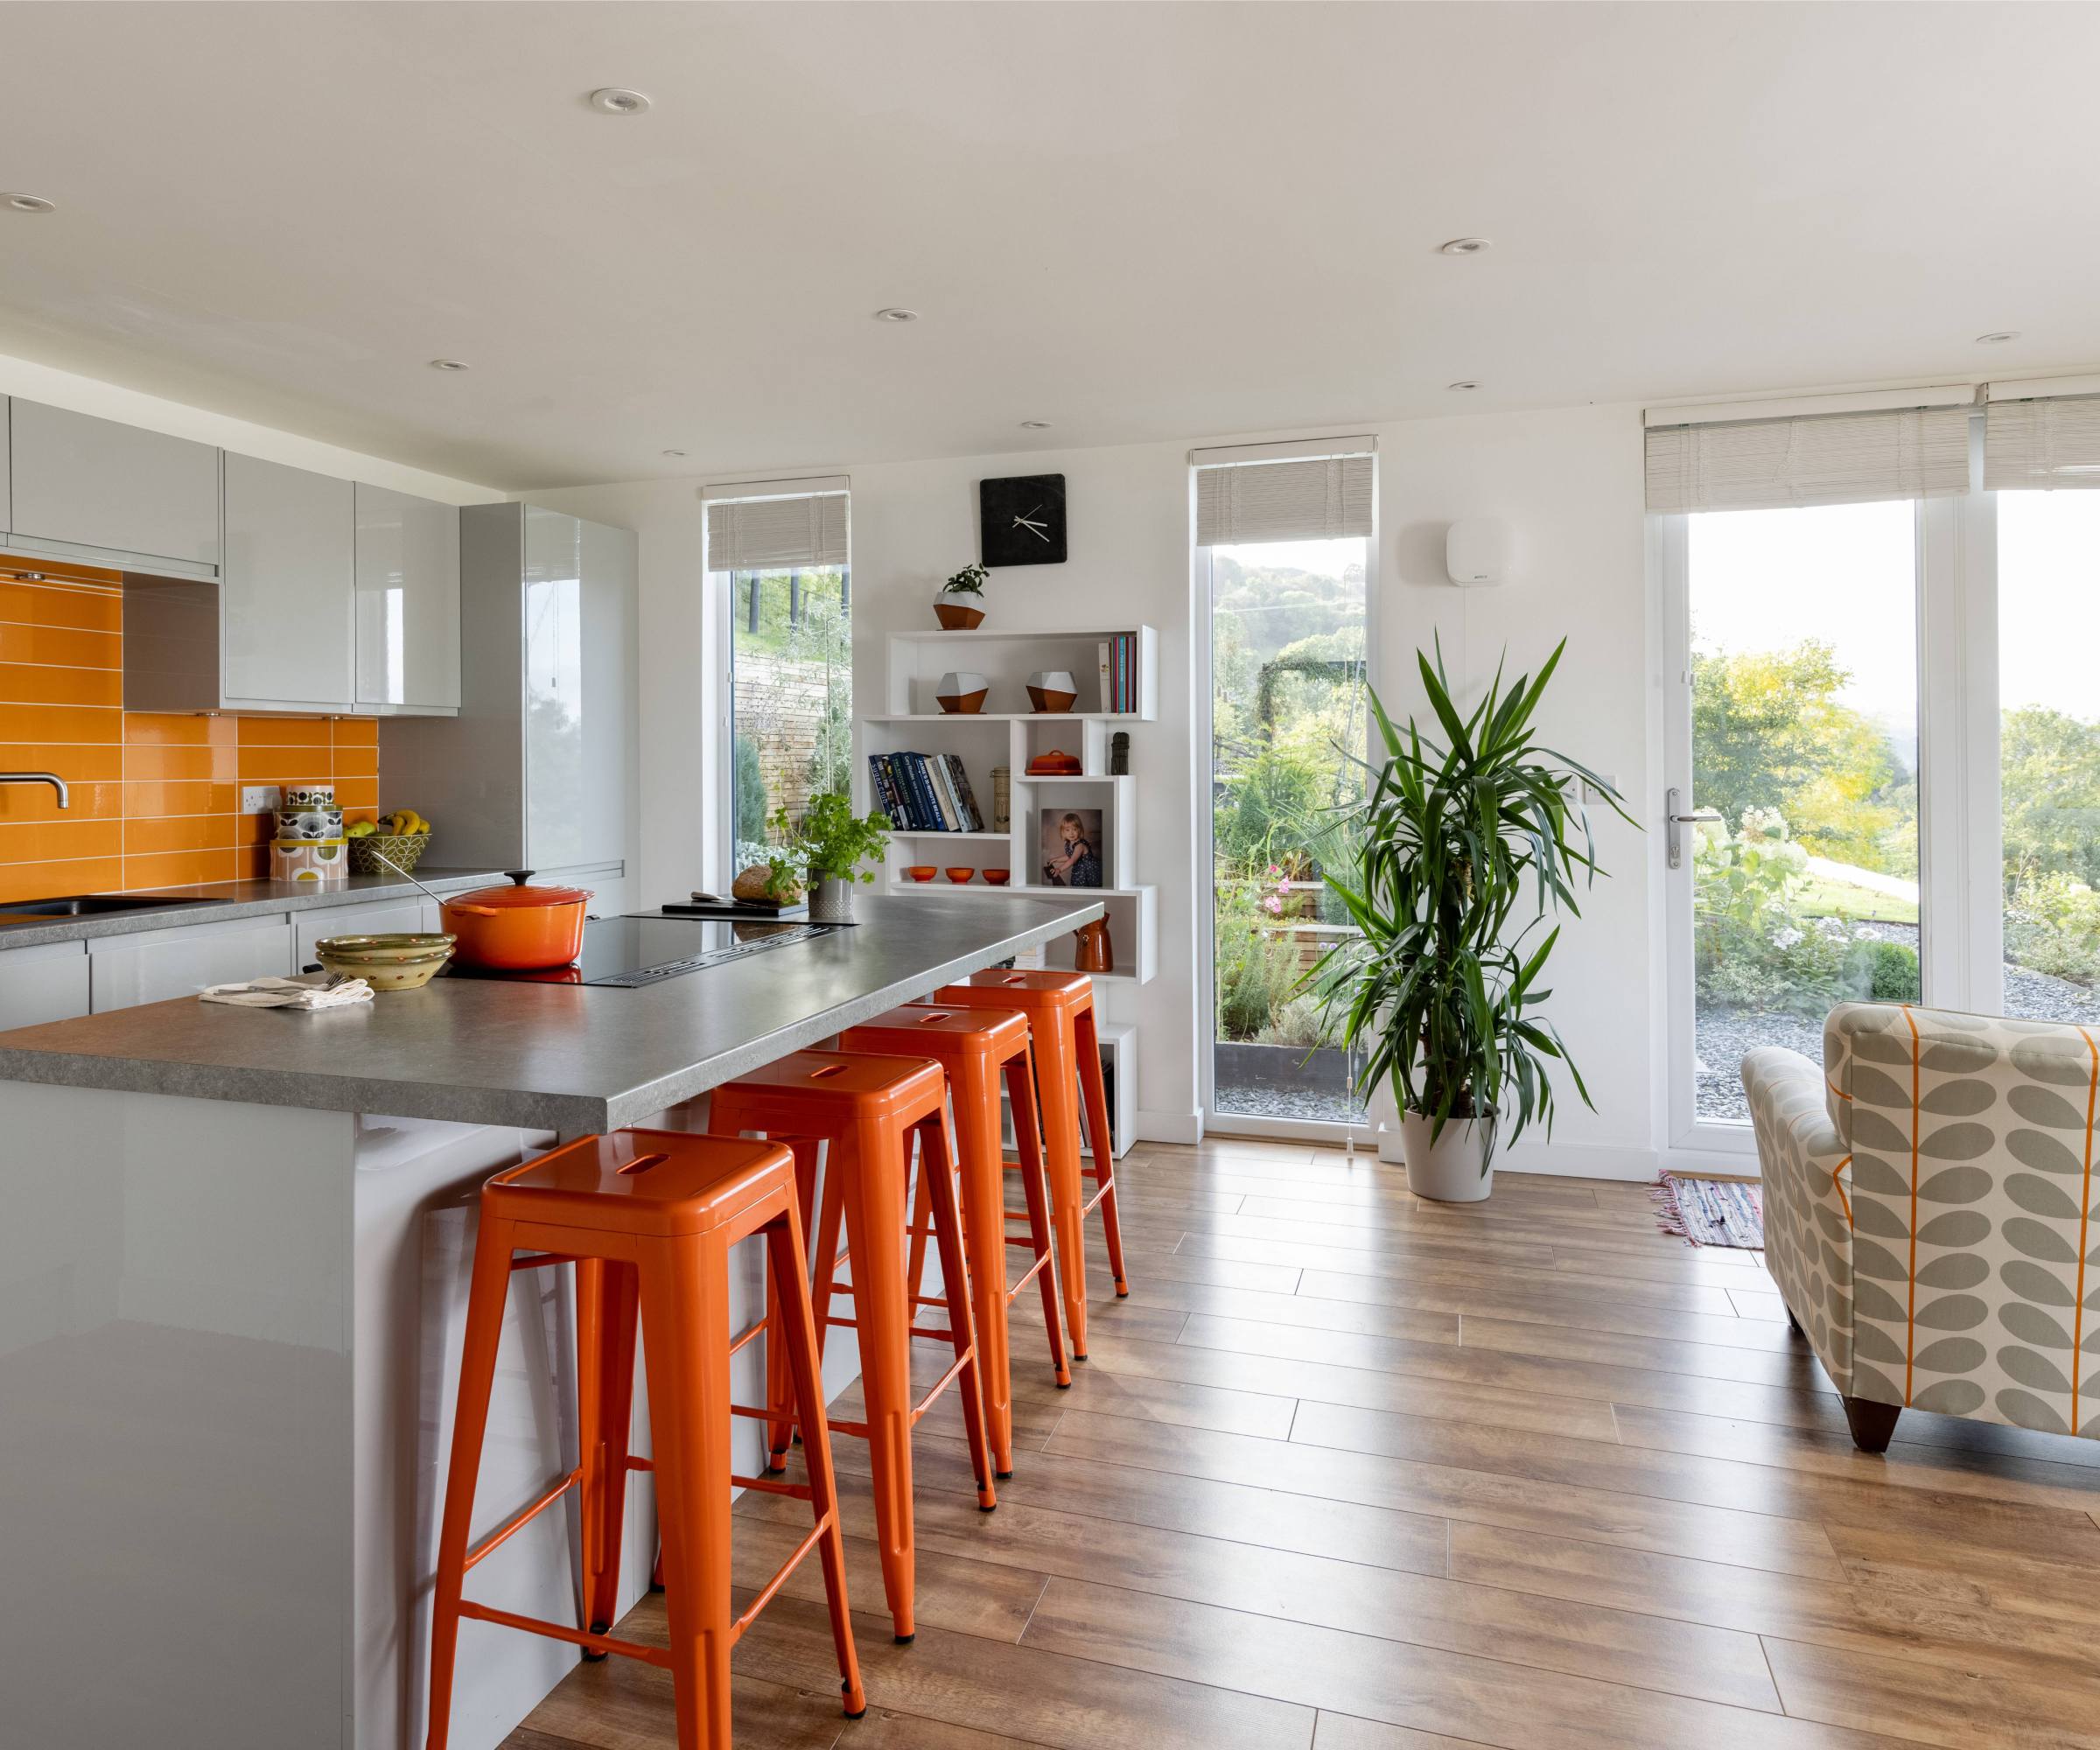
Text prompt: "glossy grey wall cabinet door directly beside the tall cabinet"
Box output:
[[357, 481, 460, 710]]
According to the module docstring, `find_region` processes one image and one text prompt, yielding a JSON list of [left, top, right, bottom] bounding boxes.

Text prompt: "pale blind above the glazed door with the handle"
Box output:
[[1648, 405, 1970, 510]]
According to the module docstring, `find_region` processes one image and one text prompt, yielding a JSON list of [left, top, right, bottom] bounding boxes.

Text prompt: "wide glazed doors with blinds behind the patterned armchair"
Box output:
[[1648, 382, 2100, 1145]]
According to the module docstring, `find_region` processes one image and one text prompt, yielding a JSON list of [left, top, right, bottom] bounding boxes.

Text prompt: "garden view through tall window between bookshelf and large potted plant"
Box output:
[[1209, 538, 1369, 1124]]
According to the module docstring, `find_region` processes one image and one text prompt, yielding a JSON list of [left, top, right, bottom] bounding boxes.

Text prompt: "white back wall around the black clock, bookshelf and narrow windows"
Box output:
[[550, 408, 1661, 1177]]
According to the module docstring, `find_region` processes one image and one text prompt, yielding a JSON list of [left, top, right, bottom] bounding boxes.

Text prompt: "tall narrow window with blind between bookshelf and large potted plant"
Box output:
[[1195, 445, 1376, 1130]]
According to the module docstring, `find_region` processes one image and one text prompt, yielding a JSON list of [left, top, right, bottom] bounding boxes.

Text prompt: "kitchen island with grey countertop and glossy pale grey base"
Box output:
[[0, 895, 1101, 1750]]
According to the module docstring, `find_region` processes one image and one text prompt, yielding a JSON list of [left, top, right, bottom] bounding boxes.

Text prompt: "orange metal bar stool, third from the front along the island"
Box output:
[[838, 1002, 1071, 1479]]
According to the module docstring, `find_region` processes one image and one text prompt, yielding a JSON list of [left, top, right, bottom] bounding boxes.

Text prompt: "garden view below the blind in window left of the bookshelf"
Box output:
[[729, 565, 852, 872]]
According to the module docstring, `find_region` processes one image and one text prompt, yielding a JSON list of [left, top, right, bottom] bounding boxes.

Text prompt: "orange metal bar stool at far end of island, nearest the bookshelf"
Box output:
[[933, 966, 1130, 1362]]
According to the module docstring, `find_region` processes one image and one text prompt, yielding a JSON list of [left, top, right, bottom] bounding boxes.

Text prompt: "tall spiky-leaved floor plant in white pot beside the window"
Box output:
[[1312, 639, 1632, 1201]]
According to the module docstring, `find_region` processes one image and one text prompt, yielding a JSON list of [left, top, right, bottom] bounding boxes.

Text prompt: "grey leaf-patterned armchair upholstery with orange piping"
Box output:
[[1743, 1002, 2100, 1437]]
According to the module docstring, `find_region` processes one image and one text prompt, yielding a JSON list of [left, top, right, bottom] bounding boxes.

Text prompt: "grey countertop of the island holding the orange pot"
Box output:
[[0, 892, 1102, 1137]]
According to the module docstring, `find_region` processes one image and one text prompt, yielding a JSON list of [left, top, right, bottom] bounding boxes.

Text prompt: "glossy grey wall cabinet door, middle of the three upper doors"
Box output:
[[220, 454, 357, 710]]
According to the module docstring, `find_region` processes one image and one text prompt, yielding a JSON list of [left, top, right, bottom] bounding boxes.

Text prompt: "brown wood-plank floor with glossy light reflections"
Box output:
[[508, 1143, 2100, 1750]]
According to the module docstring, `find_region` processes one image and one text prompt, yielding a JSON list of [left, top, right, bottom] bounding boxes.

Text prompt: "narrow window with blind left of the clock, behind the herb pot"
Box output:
[[708, 487, 852, 876]]
